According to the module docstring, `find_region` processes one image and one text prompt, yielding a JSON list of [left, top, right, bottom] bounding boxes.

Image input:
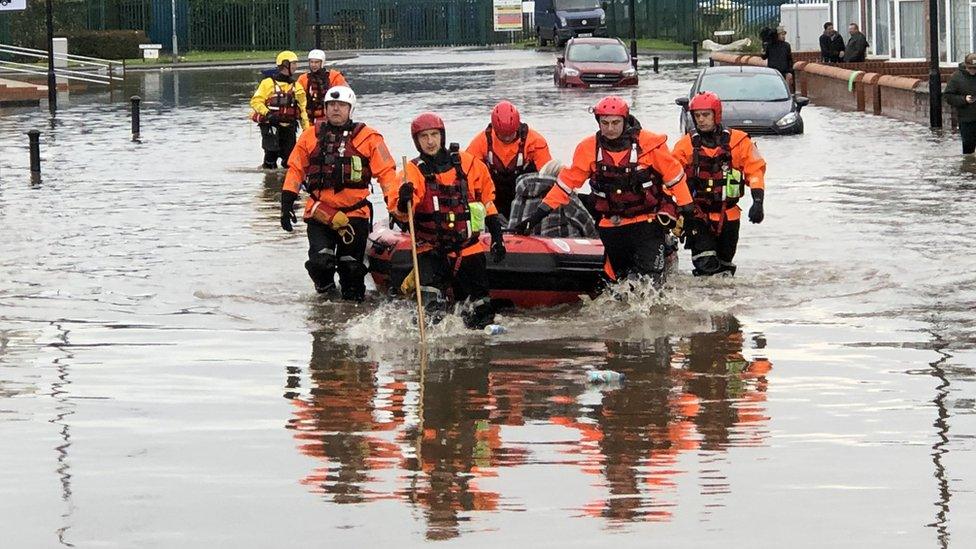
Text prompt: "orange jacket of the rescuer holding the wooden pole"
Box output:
[[386, 151, 498, 256]]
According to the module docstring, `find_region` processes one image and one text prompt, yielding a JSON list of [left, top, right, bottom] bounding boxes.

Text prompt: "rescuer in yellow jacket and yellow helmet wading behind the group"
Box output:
[[251, 51, 308, 170]]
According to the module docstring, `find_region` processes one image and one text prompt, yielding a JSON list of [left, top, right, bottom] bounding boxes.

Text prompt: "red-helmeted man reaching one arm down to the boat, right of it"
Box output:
[[516, 95, 691, 282]]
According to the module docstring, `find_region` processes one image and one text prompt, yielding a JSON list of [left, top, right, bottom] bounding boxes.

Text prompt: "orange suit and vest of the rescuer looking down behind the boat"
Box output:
[[467, 123, 552, 217]]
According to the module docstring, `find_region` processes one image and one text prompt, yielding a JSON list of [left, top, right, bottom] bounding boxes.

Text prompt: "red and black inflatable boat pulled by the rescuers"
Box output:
[[367, 226, 603, 308]]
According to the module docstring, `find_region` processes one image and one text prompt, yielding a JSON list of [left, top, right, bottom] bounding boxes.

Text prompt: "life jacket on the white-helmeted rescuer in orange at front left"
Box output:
[[305, 120, 373, 201]]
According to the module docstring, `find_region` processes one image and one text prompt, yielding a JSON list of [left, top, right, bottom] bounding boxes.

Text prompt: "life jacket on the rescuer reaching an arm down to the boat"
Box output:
[[590, 129, 666, 217]]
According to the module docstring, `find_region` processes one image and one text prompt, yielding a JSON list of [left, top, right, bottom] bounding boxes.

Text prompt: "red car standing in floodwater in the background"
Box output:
[[553, 38, 637, 88]]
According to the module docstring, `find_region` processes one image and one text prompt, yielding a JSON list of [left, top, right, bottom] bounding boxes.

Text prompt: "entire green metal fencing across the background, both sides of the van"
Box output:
[[0, 0, 784, 51]]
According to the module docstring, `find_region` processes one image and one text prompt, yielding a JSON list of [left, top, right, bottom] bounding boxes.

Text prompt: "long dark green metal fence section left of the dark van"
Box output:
[[49, 0, 522, 50]]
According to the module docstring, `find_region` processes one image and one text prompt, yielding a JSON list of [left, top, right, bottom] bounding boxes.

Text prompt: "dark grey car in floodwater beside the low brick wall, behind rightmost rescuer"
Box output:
[[674, 65, 810, 135]]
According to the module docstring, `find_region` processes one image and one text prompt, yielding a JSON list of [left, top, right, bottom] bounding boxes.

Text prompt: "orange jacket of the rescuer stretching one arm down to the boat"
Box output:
[[543, 130, 691, 227]]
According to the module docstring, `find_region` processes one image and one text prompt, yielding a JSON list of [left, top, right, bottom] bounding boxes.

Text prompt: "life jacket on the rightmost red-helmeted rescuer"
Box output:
[[685, 128, 745, 213]]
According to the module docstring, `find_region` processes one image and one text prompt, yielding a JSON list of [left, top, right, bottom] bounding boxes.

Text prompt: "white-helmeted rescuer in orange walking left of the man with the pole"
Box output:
[[281, 86, 396, 301]]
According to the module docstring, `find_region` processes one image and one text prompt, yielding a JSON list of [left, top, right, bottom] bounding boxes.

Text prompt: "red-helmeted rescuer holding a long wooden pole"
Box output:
[[387, 112, 505, 330]]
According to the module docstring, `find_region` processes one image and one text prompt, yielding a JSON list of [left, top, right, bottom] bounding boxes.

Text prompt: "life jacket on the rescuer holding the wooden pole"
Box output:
[[411, 143, 479, 252]]
